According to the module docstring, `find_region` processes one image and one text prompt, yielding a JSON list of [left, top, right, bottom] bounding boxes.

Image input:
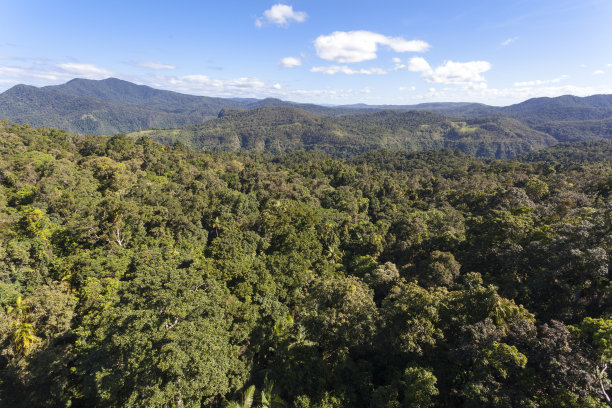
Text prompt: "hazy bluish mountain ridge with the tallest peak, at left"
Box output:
[[0, 78, 382, 135]]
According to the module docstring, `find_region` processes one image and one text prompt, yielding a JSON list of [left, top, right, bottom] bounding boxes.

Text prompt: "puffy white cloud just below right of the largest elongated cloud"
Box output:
[[408, 57, 491, 89]]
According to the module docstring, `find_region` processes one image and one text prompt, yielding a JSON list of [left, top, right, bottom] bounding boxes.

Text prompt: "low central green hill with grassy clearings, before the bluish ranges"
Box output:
[[131, 107, 556, 158]]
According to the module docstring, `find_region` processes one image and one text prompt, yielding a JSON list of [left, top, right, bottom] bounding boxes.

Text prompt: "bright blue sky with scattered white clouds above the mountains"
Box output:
[[0, 0, 612, 105]]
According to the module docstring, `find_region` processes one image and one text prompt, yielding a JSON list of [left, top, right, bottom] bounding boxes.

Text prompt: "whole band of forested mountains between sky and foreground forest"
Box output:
[[0, 78, 612, 158]]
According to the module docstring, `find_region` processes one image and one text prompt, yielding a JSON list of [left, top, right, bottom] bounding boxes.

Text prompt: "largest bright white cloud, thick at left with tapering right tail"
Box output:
[[314, 30, 429, 63]]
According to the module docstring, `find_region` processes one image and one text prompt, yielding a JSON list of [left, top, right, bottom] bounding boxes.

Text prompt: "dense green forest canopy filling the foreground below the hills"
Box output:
[[0, 116, 612, 408]]
